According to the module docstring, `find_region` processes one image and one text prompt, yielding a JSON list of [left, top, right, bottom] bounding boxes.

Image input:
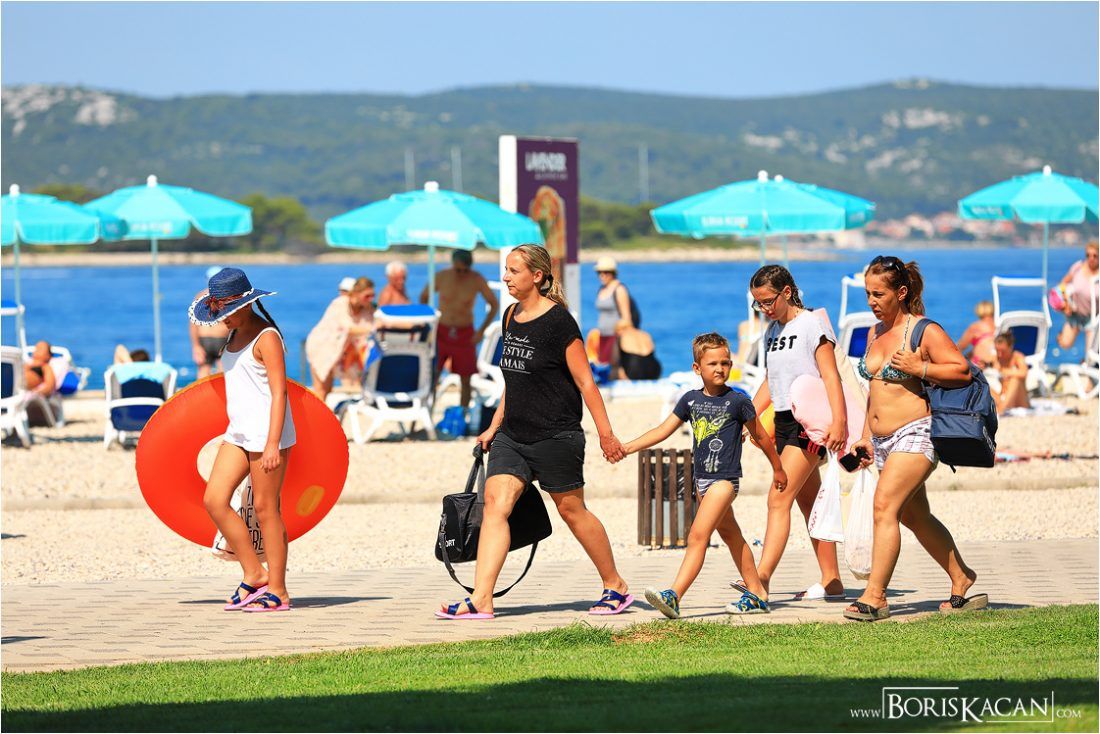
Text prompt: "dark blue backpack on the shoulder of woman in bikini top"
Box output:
[[910, 319, 997, 471]]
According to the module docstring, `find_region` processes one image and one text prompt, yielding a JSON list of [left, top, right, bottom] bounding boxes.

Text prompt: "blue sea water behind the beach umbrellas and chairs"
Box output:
[[2, 247, 1082, 388]]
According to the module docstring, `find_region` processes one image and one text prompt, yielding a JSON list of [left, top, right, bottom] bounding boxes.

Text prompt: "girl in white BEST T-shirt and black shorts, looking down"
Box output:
[[733, 265, 848, 601]]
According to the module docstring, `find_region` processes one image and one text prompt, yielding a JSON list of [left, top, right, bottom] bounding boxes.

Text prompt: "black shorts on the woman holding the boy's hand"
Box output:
[[485, 430, 584, 492]]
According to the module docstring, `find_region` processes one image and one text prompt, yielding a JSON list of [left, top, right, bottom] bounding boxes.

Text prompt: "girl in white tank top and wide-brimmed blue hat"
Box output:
[[188, 267, 295, 612]]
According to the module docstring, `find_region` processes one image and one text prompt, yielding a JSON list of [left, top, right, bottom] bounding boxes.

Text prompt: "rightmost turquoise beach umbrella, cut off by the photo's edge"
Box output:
[[959, 166, 1100, 283]]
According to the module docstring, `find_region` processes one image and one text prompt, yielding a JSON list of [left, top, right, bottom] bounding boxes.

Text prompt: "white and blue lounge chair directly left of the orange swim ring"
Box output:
[[103, 362, 176, 448]]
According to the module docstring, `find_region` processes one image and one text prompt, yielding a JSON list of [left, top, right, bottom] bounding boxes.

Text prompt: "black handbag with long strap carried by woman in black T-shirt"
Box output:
[[436, 443, 552, 598]]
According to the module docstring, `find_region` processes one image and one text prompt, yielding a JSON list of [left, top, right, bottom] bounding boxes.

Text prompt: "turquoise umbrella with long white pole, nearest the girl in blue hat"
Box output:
[[85, 176, 252, 362]]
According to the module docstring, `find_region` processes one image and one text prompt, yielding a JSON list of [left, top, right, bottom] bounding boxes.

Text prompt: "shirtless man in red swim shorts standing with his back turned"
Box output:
[[420, 250, 499, 407]]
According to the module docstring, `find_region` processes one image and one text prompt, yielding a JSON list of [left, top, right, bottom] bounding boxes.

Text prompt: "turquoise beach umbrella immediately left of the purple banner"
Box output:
[[325, 180, 542, 303]]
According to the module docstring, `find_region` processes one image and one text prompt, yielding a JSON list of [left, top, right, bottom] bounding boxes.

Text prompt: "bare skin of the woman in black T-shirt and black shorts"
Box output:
[[440, 253, 628, 614]]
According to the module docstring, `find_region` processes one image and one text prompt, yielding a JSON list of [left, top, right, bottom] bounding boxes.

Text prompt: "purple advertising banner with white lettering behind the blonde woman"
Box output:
[[502, 138, 581, 283]]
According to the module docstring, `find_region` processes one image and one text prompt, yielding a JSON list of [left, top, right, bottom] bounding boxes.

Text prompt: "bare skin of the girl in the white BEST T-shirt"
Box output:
[[751, 285, 848, 594]]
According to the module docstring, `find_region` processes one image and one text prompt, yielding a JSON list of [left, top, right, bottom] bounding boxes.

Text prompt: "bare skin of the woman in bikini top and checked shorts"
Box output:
[[848, 269, 978, 612]]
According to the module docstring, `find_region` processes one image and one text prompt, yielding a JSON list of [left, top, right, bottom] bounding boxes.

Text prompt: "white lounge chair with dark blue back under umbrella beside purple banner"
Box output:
[[337, 339, 436, 443]]
